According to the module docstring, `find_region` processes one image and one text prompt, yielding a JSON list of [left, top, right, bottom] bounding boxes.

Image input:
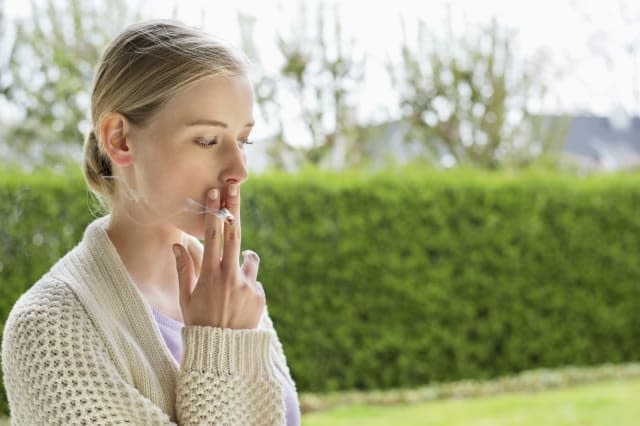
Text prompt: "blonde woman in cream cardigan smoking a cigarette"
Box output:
[[2, 21, 300, 425]]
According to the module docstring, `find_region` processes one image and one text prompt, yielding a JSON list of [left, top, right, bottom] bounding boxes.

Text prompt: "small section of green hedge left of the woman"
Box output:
[[0, 172, 92, 414]]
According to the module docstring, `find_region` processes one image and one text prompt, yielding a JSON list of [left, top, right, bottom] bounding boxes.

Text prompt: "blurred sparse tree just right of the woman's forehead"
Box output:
[[241, 1, 366, 169]]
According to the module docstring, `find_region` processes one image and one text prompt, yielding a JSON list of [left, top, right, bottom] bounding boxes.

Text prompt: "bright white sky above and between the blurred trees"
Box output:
[[5, 0, 640, 141]]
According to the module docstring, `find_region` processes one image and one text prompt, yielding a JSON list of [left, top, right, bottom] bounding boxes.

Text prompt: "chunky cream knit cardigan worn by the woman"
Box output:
[[2, 217, 295, 426]]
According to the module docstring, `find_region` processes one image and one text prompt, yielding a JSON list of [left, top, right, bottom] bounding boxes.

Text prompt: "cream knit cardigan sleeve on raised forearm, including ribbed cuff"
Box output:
[[176, 326, 285, 425]]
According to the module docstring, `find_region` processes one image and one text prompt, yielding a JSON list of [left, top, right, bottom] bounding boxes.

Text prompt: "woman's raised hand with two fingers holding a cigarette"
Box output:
[[173, 183, 266, 329]]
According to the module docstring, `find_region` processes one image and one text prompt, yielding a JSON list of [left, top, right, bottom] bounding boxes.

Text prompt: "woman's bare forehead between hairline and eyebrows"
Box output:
[[158, 76, 253, 126]]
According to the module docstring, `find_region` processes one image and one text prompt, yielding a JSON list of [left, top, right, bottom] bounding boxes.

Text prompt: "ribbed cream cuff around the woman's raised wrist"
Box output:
[[180, 325, 276, 377]]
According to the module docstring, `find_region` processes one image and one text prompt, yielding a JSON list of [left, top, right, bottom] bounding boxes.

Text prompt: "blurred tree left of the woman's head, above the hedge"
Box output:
[[6, 0, 139, 169]]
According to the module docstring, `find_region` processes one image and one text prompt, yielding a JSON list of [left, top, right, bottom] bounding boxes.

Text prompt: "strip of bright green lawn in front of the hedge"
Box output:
[[302, 379, 640, 426]]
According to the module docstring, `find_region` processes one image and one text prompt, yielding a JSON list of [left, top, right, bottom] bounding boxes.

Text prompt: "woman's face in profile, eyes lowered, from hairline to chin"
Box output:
[[120, 76, 254, 239]]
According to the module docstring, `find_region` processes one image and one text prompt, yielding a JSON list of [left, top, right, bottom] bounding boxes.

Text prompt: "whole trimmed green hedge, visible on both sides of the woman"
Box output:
[[0, 170, 640, 416]]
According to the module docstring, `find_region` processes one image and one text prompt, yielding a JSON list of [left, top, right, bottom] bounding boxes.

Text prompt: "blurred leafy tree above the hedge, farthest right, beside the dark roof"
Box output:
[[387, 15, 567, 169]]
